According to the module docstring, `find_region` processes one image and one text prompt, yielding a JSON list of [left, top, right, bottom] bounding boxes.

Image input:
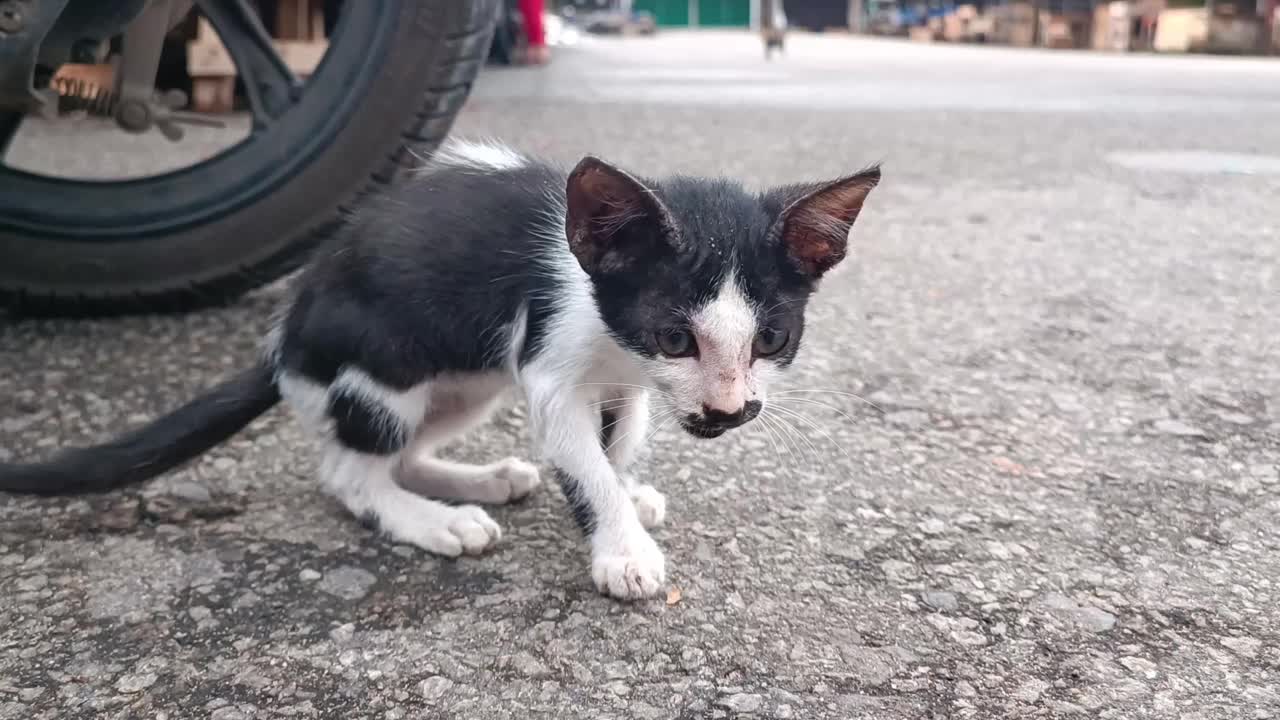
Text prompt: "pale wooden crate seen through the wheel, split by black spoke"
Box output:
[[187, 0, 329, 113]]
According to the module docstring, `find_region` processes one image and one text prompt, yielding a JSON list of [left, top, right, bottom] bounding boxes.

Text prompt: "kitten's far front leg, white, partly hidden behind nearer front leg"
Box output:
[[600, 388, 667, 528]]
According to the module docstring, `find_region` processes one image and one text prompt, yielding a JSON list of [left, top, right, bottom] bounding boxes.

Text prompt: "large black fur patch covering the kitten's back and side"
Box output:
[[280, 164, 572, 389]]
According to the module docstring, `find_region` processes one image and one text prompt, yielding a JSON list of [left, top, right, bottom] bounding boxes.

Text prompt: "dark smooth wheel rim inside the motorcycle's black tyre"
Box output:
[[0, 0, 402, 242]]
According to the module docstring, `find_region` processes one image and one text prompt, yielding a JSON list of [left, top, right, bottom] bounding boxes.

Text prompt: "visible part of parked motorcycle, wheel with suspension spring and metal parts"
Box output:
[[0, 0, 500, 315]]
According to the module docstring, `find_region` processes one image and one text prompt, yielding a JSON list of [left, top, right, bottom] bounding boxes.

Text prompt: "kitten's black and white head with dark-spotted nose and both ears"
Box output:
[[566, 158, 879, 437]]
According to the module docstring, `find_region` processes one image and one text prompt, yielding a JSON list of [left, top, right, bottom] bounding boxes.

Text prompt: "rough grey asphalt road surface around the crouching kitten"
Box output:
[[0, 29, 1280, 720]]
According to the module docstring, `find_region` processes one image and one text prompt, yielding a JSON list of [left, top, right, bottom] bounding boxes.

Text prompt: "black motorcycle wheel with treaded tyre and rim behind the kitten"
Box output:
[[0, 0, 495, 315]]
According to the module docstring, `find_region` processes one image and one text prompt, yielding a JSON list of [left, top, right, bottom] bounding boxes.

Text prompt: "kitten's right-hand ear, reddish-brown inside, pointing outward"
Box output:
[[773, 167, 879, 279]]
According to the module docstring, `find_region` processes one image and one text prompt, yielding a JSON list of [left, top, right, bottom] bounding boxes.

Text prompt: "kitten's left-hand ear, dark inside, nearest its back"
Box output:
[[564, 156, 675, 273]]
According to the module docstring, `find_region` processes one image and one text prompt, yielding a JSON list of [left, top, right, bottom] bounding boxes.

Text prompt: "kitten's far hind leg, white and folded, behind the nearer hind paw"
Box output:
[[397, 386, 541, 505]]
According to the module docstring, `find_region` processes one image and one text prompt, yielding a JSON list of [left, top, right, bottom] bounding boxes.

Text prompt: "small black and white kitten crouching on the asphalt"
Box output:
[[0, 137, 879, 598]]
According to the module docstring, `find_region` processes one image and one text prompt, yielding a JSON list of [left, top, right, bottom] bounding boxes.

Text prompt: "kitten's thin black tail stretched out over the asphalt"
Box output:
[[0, 365, 280, 495]]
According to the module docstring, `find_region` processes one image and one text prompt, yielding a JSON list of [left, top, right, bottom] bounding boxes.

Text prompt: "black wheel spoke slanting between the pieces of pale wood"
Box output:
[[197, 0, 302, 128]]
